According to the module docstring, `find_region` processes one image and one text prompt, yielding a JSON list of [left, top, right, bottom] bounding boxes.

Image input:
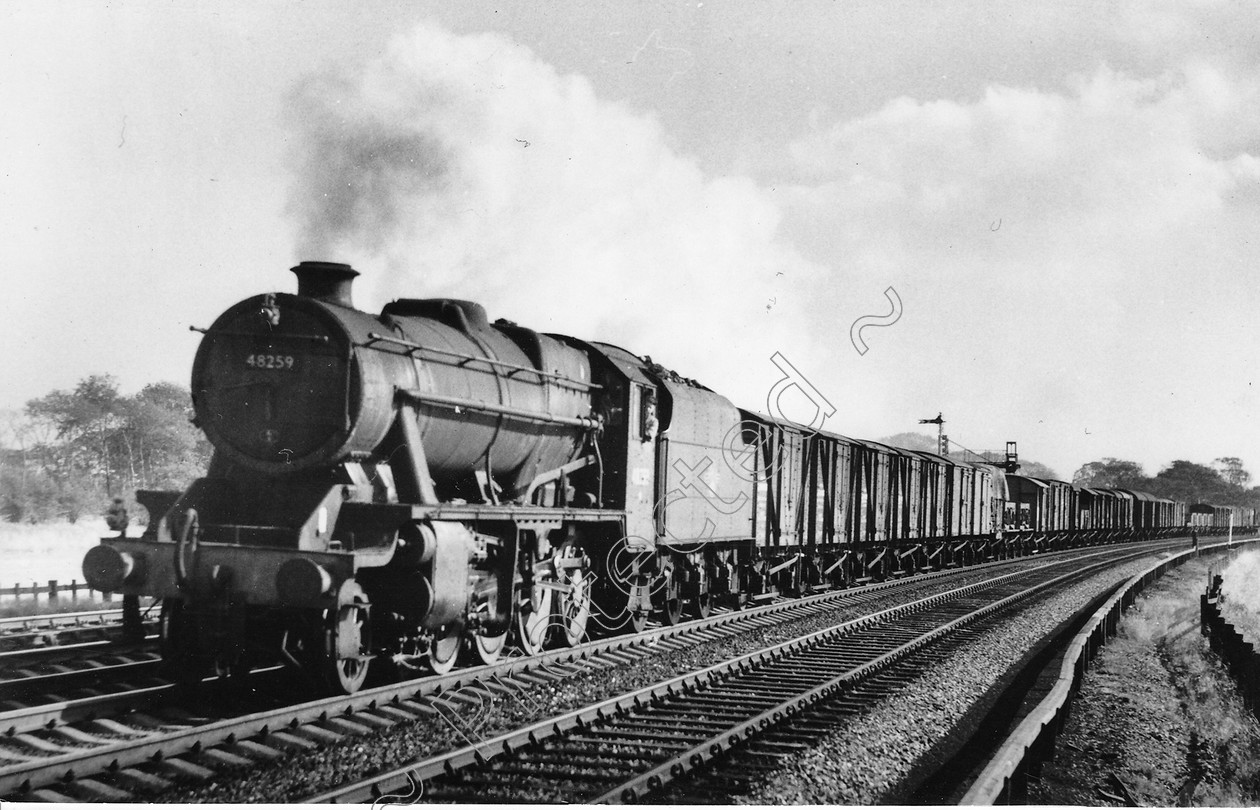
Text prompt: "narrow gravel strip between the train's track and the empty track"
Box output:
[[146, 559, 1078, 802]]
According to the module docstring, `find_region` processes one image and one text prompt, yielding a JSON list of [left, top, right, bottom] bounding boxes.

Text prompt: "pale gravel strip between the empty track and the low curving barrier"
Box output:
[[735, 558, 1169, 805]]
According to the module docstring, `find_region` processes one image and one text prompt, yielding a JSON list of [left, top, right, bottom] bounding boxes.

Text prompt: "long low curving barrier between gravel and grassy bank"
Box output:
[[959, 539, 1260, 805]]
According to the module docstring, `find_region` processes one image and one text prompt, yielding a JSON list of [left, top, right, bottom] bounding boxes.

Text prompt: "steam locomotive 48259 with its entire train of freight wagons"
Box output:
[[83, 262, 1255, 692]]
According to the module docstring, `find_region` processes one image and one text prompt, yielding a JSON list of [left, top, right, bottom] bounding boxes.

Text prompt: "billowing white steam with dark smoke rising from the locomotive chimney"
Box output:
[[283, 25, 818, 413]]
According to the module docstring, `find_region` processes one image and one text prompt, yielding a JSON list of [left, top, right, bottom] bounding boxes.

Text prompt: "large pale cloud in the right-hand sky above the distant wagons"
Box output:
[[784, 60, 1260, 471]]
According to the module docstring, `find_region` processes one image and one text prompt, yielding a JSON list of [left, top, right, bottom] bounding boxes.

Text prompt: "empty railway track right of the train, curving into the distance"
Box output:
[[307, 539, 1179, 802]]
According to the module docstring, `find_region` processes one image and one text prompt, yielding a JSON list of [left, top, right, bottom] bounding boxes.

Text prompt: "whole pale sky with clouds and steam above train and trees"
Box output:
[[0, 0, 1260, 477]]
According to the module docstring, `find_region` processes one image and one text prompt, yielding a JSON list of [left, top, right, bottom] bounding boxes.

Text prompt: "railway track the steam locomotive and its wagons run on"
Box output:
[[0, 545, 1199, 801]]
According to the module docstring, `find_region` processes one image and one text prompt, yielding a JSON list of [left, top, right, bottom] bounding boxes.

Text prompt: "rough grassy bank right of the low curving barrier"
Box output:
[[1027, 552, 1260, 806]]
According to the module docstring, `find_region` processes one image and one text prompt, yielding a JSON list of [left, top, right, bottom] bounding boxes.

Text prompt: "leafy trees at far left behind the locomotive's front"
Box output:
[[0, 374, 210, 523]]
